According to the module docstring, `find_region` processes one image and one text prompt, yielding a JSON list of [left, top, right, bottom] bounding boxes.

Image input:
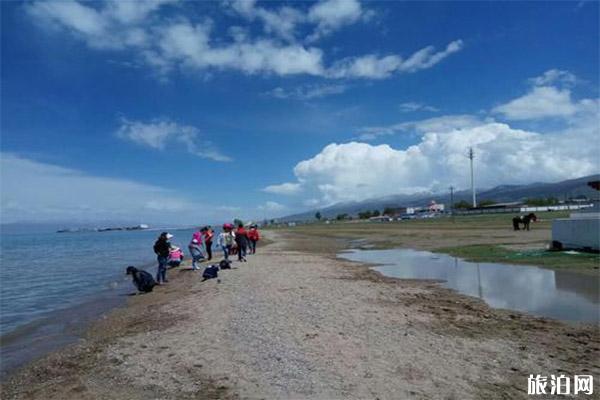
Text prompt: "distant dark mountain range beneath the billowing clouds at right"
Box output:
[[278, 174, 600, 222]]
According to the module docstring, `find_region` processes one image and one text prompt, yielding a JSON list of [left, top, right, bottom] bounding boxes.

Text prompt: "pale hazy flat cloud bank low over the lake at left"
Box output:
[[0, 153, 197, 223]]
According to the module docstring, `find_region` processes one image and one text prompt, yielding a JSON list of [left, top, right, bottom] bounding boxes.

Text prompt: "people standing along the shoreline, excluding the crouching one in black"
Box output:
[[154, 223, 260, 285]]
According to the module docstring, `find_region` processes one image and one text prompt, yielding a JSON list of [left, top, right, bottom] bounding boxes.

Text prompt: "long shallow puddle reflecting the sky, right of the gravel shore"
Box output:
[[340, 249, 600, 323]]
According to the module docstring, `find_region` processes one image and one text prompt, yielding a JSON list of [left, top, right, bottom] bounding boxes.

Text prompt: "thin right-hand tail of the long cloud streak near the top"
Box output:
[[327, 40, 463, 79]]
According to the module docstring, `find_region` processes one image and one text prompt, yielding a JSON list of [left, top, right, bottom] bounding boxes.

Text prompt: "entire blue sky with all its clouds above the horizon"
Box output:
[[1, 0, 600, 223]]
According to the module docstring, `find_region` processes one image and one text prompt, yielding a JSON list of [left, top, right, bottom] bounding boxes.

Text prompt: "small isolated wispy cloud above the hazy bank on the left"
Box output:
[[117, 119, 231, 161]]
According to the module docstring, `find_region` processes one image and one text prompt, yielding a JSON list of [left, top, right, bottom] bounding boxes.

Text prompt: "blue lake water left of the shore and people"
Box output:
[[0, 230, 198, 376]]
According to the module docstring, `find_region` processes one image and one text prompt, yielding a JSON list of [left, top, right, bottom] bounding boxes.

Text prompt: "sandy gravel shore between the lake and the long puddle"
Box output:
[[3, 233, 600, 399]]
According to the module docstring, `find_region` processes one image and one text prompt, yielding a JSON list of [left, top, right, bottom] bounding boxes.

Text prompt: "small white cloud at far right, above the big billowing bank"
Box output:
[[492, 86, 579, 120]]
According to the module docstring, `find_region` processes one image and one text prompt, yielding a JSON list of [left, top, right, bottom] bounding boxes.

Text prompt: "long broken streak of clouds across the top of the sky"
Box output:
[[26, 0, 462, 79]]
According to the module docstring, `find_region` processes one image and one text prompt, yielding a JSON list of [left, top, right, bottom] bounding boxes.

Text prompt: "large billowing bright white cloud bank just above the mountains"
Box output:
[[270, 104, 600, 206]]
